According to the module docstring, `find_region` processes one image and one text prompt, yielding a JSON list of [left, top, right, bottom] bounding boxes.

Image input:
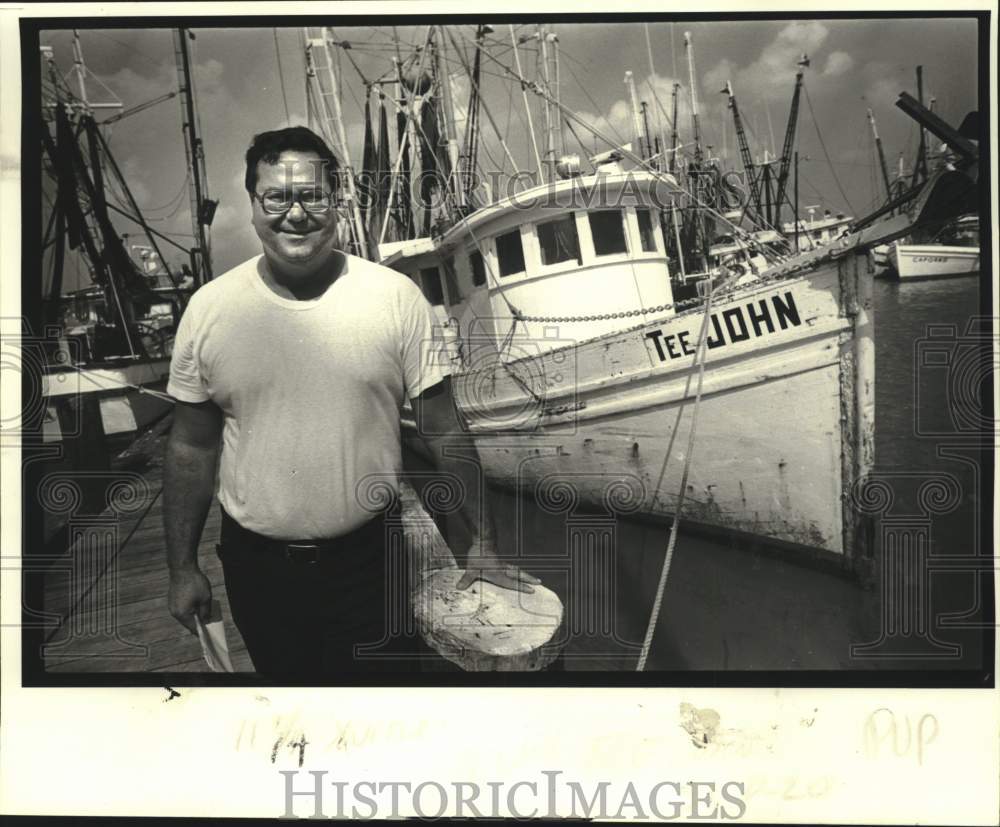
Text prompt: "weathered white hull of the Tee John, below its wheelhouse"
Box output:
[[404, 249, 874, 564]]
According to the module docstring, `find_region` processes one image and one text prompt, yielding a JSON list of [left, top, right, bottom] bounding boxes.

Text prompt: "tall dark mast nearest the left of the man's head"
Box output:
[[174, 28, 218, 286]]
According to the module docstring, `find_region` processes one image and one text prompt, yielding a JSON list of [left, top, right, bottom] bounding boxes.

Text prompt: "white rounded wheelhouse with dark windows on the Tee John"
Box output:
[[380, 170, 677, 364]]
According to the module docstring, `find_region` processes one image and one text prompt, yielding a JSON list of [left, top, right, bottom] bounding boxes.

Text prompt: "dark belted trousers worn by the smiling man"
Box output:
[[217, 510, 427, 679]]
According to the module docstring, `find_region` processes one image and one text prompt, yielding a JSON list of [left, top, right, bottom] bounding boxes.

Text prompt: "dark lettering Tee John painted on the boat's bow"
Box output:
[[643, 291, 802, 362]]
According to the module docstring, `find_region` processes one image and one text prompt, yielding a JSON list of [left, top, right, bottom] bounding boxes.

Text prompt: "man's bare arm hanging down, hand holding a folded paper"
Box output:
[[163, 402, 223, 632]]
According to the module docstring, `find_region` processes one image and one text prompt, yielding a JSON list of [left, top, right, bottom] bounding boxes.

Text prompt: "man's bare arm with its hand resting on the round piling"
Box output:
[[410, 376, 541, 592]]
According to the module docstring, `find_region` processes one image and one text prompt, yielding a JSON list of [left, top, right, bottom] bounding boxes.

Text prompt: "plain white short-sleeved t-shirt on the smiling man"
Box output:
[[167, 255, 449, 539]]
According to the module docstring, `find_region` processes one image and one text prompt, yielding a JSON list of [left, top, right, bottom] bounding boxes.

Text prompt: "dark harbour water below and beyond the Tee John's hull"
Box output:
[[472, 278, 990, 670]]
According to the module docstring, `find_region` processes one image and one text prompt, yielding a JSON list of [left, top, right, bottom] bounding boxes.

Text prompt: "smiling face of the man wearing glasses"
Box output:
[[251, 150, 337, 275]]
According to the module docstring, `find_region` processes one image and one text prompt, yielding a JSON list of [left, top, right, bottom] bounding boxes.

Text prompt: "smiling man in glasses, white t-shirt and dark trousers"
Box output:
[[164, 127, 538, 674]]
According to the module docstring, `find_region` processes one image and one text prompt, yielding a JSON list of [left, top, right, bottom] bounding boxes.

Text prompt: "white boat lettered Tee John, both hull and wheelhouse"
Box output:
[[383, 170, 874, 562]]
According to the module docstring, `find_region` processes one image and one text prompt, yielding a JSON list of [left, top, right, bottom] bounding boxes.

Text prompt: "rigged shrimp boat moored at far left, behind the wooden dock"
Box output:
[[36, 30, 215, 452]]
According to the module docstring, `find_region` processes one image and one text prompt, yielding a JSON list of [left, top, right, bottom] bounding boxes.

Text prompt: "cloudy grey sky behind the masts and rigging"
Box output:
[[41, 17, 979, 290]]
